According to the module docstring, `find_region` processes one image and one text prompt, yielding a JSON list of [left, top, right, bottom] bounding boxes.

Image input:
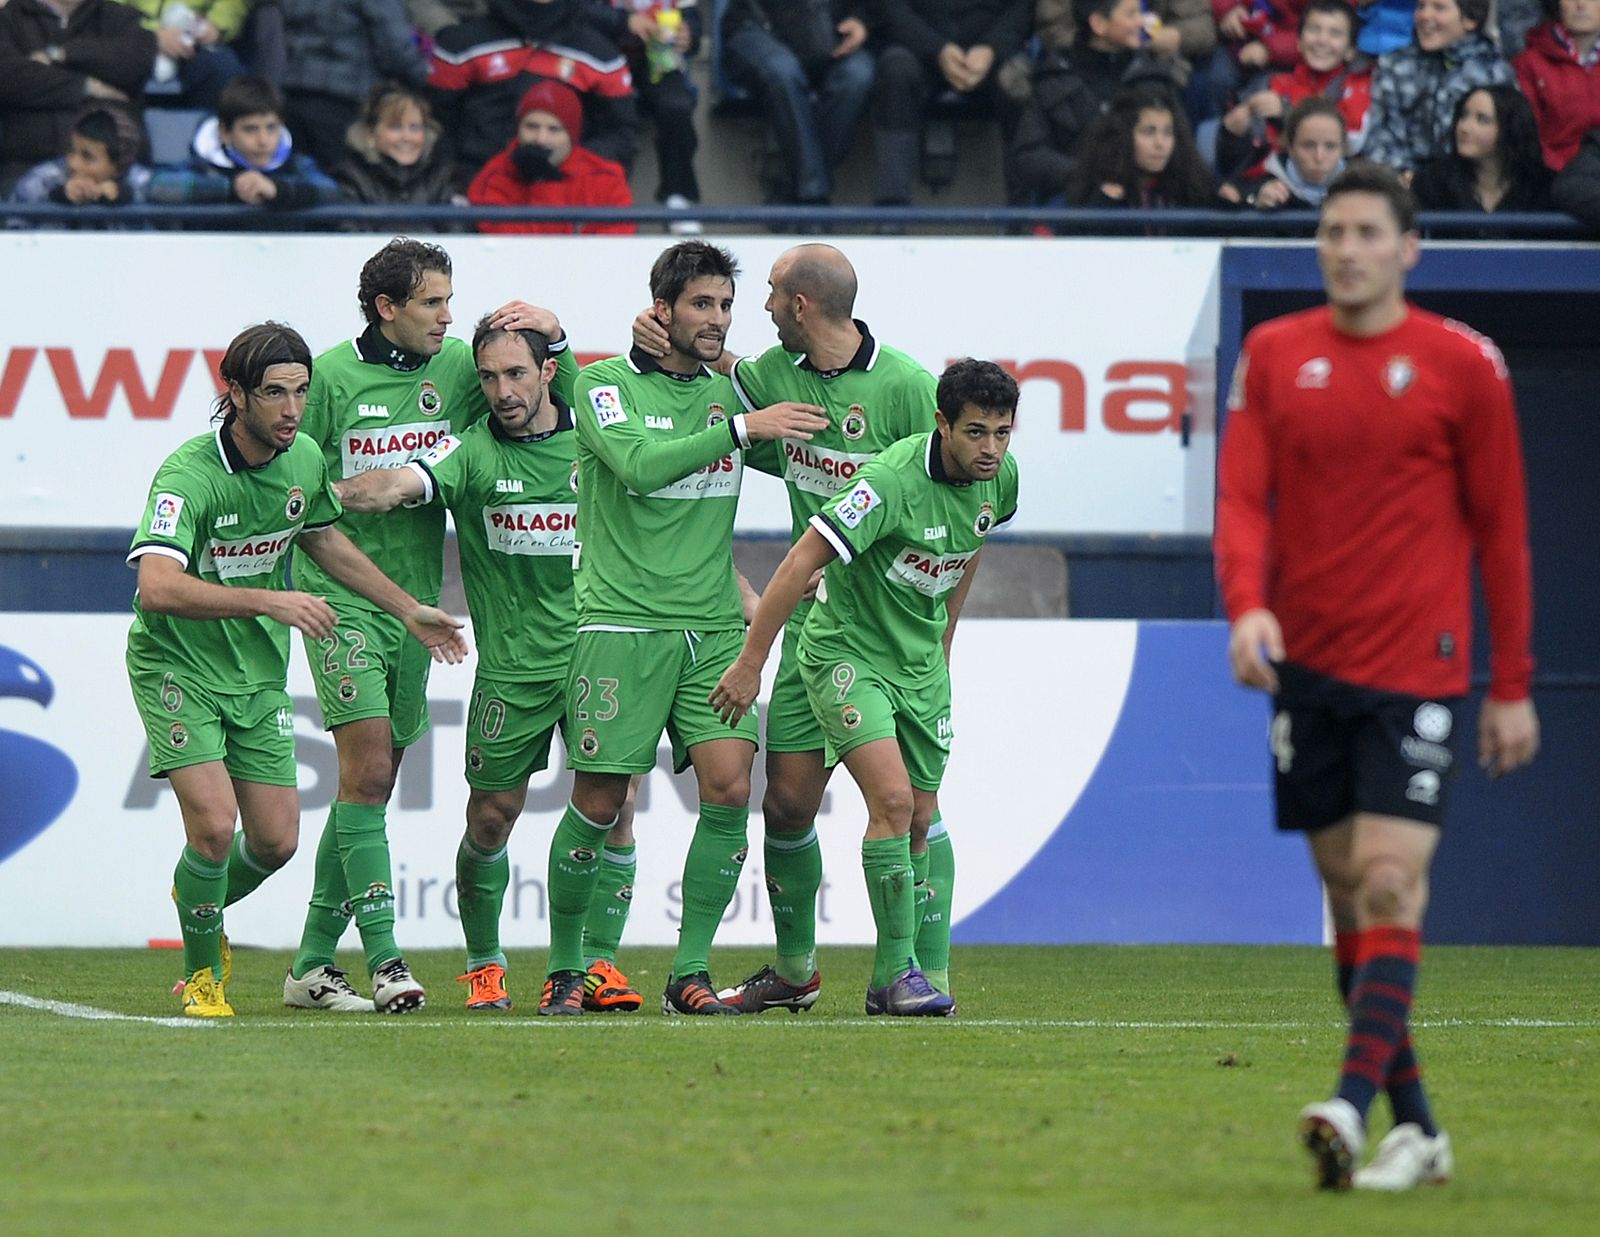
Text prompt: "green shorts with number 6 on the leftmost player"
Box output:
[[128, 669, 296, 786]]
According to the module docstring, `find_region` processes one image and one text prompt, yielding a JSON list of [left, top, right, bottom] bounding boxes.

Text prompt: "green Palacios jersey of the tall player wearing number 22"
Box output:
[[294, 328, 576, 610]]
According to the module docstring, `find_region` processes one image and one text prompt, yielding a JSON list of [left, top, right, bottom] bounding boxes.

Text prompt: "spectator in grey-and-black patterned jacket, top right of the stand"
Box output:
[[1362, 0, 1515, 173]]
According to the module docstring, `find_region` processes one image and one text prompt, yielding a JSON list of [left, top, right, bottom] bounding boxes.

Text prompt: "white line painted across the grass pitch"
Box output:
[[0, 991, 1600, 1031]]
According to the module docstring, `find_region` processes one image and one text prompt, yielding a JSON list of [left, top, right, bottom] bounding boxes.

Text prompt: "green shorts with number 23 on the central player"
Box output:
[[566, 631, 760, 773]]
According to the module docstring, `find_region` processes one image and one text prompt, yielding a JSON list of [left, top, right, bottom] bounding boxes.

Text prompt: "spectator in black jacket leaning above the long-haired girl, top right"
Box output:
[[1010, 0, 1181, 202]]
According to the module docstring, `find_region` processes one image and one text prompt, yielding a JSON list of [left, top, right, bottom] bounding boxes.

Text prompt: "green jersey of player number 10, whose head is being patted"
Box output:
[[406, 403, 578, 682]]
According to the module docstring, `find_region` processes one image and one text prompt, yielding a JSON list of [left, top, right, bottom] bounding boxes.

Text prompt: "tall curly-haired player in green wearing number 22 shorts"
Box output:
[[283, 238, 571, 1013]]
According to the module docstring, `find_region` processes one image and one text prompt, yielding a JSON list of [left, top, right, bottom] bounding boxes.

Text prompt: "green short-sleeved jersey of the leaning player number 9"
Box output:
[[800, 434, 1018, 687]]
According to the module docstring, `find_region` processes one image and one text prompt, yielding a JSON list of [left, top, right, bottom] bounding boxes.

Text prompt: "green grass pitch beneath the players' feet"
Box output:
[[0, 947, 1600, 1237]]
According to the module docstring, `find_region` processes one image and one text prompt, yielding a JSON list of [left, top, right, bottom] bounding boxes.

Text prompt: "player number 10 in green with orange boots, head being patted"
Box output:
[[324, 317, 642, 1011]]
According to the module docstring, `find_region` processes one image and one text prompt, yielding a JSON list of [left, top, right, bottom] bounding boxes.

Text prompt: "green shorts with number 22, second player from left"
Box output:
[[306, 598, 434, 747]]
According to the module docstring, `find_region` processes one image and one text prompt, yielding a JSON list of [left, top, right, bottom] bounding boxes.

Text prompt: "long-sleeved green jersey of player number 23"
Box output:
[[573, 349, 744, 632]]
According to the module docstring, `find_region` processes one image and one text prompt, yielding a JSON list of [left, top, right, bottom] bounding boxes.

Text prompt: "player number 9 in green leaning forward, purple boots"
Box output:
[[710, 358, 1016, 1015]]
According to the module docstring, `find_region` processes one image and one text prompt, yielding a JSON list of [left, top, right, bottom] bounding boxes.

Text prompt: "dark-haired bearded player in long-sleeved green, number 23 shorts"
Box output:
[[541, 240, 827, 1013]]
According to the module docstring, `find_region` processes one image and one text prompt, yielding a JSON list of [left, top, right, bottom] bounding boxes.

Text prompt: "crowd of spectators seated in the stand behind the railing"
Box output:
[[0, 0, 1600, 232]]
